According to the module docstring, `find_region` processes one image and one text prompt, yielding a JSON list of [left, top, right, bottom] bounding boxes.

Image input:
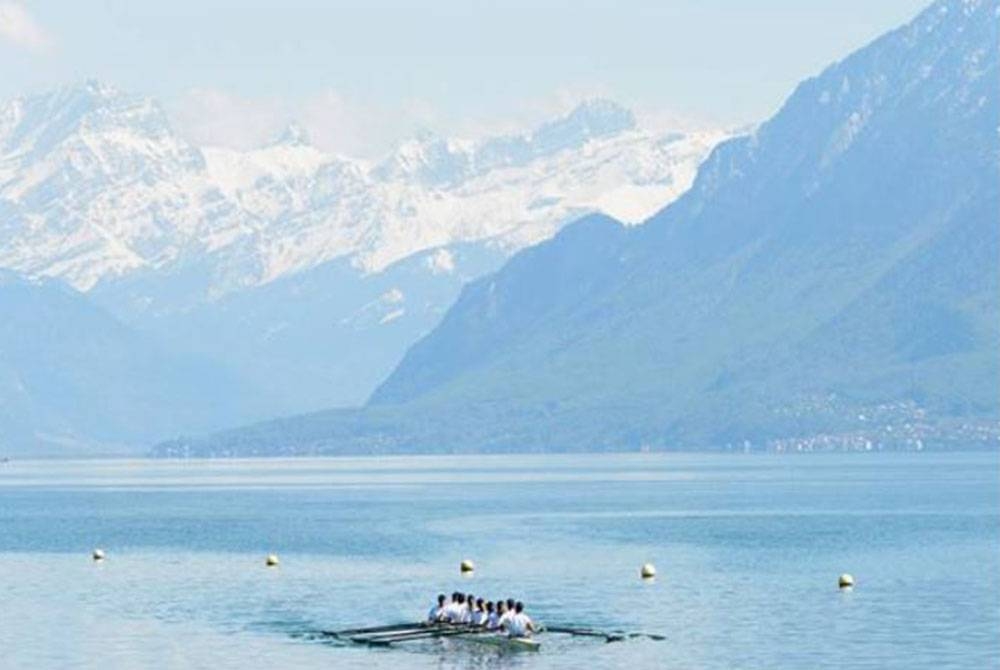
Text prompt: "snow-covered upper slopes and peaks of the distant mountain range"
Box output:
[[0, 82, 724, 298]]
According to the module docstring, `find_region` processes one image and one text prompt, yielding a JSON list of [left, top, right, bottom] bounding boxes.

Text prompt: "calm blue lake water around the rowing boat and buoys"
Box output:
[[0, 453, 1000, 670]]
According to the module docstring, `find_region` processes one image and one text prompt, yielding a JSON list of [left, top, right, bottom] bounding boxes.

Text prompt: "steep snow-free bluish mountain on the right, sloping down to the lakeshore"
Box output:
[[156, 0, 1000, 455]]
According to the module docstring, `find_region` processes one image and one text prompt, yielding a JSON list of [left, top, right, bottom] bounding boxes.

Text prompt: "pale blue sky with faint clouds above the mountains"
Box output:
[[0, 0, 927, 156]]
